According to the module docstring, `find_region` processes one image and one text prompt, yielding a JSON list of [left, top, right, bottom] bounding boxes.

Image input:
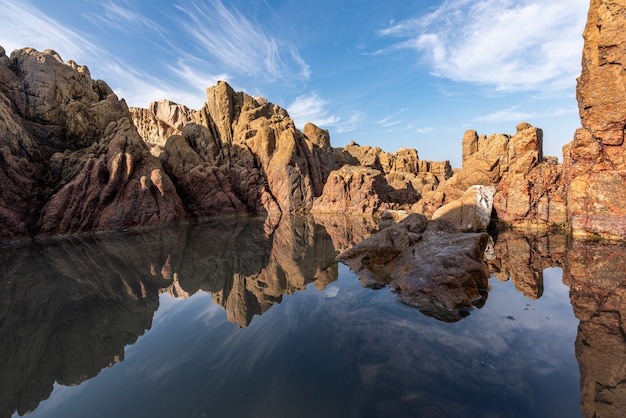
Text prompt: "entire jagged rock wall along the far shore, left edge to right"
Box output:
[[0, 0, 626, 245]]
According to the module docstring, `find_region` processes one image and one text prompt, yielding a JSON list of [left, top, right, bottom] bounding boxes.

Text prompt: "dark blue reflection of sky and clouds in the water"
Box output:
[[23, 265, 580, 417]]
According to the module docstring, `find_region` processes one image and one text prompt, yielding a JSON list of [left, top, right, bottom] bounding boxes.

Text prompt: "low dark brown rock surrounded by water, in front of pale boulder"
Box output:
[[337, 214, 489, 322]]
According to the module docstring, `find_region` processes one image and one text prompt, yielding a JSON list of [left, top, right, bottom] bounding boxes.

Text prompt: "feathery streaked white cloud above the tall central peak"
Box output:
[[177, 0, 311, 79]]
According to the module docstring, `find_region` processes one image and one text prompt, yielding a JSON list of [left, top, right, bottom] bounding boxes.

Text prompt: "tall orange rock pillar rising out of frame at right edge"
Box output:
[[563, 0, 626, 239]]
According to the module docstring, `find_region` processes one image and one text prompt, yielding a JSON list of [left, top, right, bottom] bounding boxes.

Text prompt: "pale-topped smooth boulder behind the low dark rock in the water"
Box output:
[[432, 185, 496, 232]]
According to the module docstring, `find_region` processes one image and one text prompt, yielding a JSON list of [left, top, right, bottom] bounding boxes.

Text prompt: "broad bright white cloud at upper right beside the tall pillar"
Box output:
[[377, 0, 589, 91]]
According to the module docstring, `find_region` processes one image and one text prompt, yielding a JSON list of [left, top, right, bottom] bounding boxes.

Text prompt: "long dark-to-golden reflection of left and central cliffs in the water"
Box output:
[[0, 216, 337, 417]]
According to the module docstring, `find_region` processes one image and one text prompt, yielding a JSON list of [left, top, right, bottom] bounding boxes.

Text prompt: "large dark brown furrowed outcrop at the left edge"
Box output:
[[0, 48, 186, 240]]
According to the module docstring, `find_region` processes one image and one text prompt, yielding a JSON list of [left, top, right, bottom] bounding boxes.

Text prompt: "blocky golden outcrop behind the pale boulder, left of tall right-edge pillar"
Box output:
[[413, 122, 567, 230]]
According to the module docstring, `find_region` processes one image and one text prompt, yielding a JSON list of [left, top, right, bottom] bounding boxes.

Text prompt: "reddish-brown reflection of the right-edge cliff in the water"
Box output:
[[563, 241, 626, 418]]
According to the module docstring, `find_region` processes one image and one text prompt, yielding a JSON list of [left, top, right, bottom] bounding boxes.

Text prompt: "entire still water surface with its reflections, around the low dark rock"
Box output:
[[0, 217, 626, 417]]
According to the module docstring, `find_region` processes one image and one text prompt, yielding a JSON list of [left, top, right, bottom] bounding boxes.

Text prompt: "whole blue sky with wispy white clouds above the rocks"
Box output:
[[0, 0, 589, 167]]
